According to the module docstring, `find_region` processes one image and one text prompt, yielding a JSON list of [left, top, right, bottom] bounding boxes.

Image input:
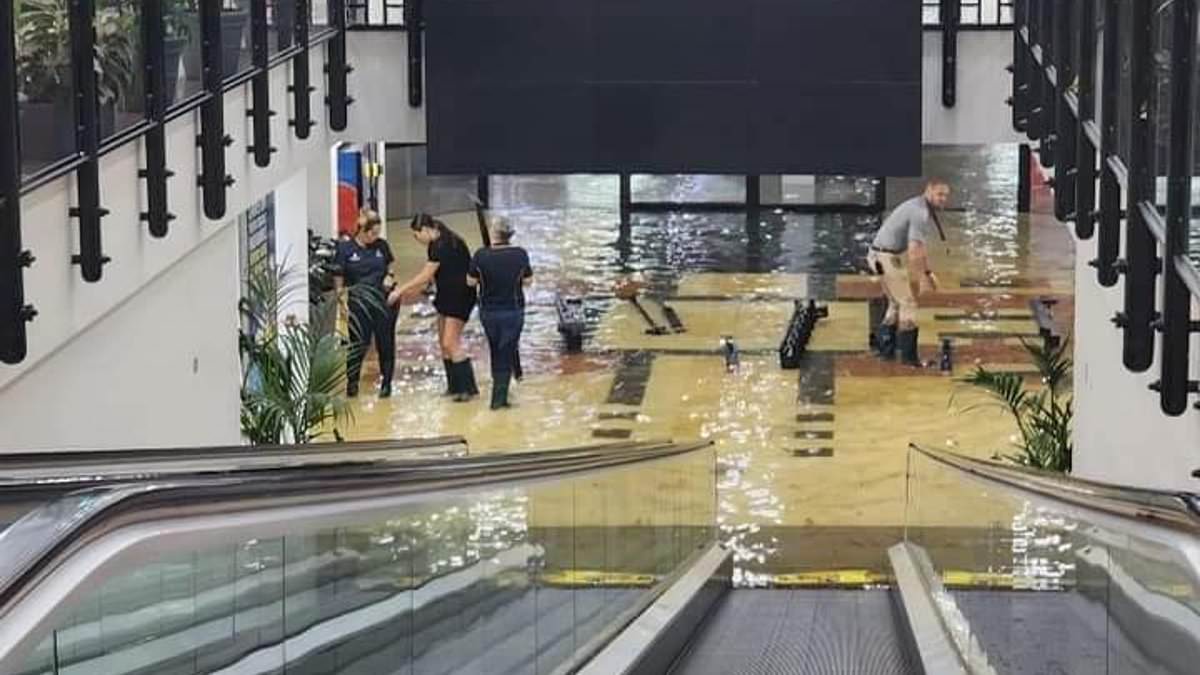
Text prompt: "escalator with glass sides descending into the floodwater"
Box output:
[[0, 440, 1200, 675]]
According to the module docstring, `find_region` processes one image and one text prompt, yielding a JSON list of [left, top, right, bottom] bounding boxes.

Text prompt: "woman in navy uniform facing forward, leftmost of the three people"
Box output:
[[334, 209, 396, 399]]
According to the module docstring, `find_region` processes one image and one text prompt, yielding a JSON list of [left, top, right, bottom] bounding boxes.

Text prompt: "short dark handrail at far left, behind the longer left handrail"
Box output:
[[0, 436, 467, 466]]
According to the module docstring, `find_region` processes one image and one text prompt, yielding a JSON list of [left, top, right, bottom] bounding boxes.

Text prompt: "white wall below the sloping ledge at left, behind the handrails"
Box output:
[[0, 227, 240, 452]]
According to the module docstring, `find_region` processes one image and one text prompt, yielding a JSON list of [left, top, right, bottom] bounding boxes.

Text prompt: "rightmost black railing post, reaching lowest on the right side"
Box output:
[[1159, 0, 1196, 416]]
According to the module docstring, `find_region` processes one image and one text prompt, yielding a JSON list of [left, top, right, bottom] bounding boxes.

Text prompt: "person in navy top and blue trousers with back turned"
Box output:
[[467, 217, 533, 410]]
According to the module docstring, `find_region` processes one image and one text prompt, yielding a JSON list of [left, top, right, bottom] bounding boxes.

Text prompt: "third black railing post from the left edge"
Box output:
[[138, 0, 175, 238]]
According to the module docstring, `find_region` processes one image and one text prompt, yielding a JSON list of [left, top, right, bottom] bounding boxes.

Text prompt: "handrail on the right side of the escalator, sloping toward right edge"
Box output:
[[910, 443, 1200, 536]]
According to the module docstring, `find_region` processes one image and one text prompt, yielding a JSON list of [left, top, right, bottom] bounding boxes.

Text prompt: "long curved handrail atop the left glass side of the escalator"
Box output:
[[0, 441, 712, 615]]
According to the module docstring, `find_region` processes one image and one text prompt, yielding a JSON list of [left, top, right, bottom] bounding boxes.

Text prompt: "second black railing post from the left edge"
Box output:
[[70, 0, 109, 282]]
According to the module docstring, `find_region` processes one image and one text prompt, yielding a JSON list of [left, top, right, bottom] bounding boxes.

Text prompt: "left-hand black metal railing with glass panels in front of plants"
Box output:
[[0, 0, 350, 364]]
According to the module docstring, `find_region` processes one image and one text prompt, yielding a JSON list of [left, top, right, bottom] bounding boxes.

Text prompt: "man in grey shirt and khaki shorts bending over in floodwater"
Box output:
[[866, 178, 950, 366]]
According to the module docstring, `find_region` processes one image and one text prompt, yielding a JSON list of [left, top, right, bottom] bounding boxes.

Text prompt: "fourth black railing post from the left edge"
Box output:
[[196, 2, 234, 220]]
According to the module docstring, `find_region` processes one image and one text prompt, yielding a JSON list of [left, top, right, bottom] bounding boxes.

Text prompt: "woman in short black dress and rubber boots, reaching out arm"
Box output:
[[388, 214, 479, 402]]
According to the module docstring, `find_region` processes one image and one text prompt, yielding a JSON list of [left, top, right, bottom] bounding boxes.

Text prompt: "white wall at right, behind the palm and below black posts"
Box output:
[[1074, 228, 1200, 490]]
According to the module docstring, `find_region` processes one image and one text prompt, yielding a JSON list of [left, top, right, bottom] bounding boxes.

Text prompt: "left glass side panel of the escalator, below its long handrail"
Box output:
[[0, 448, 716, 675]]
